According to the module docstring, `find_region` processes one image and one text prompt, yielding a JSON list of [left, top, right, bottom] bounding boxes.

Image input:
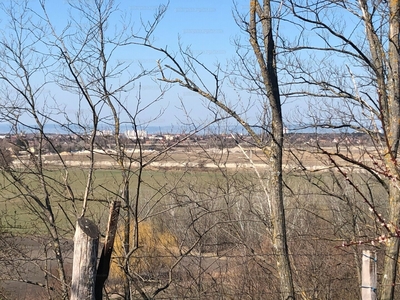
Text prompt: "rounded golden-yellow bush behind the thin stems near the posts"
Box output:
[[110, 222, 177, 278]]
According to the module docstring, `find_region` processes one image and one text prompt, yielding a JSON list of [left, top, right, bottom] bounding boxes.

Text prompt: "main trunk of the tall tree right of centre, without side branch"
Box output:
[[249, 0, 295, 300]]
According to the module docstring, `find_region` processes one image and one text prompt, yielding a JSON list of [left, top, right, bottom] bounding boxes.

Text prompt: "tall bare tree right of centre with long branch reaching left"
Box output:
[[144, 0, 295, 299]]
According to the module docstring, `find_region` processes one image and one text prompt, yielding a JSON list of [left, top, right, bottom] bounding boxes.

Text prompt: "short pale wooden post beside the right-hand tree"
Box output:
[[361, 250, 377, 300]]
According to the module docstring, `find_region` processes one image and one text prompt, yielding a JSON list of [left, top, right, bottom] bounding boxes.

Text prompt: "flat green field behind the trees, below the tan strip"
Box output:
[[0, 159, 383, 236]]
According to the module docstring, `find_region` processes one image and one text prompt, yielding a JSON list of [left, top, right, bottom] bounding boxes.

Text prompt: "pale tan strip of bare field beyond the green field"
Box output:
[[37, 147, 379, 171]]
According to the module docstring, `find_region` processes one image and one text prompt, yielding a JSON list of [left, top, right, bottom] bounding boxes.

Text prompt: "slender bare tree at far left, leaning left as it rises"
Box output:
[[0, 2, 69, 299]]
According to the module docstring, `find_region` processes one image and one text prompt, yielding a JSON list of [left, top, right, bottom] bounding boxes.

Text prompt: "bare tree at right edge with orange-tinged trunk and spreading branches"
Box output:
[[282, 0, 400, 300]]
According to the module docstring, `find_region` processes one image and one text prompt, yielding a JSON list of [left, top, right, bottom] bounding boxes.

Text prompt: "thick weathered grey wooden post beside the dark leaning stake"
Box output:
[[71, 217, 99, 300]]
